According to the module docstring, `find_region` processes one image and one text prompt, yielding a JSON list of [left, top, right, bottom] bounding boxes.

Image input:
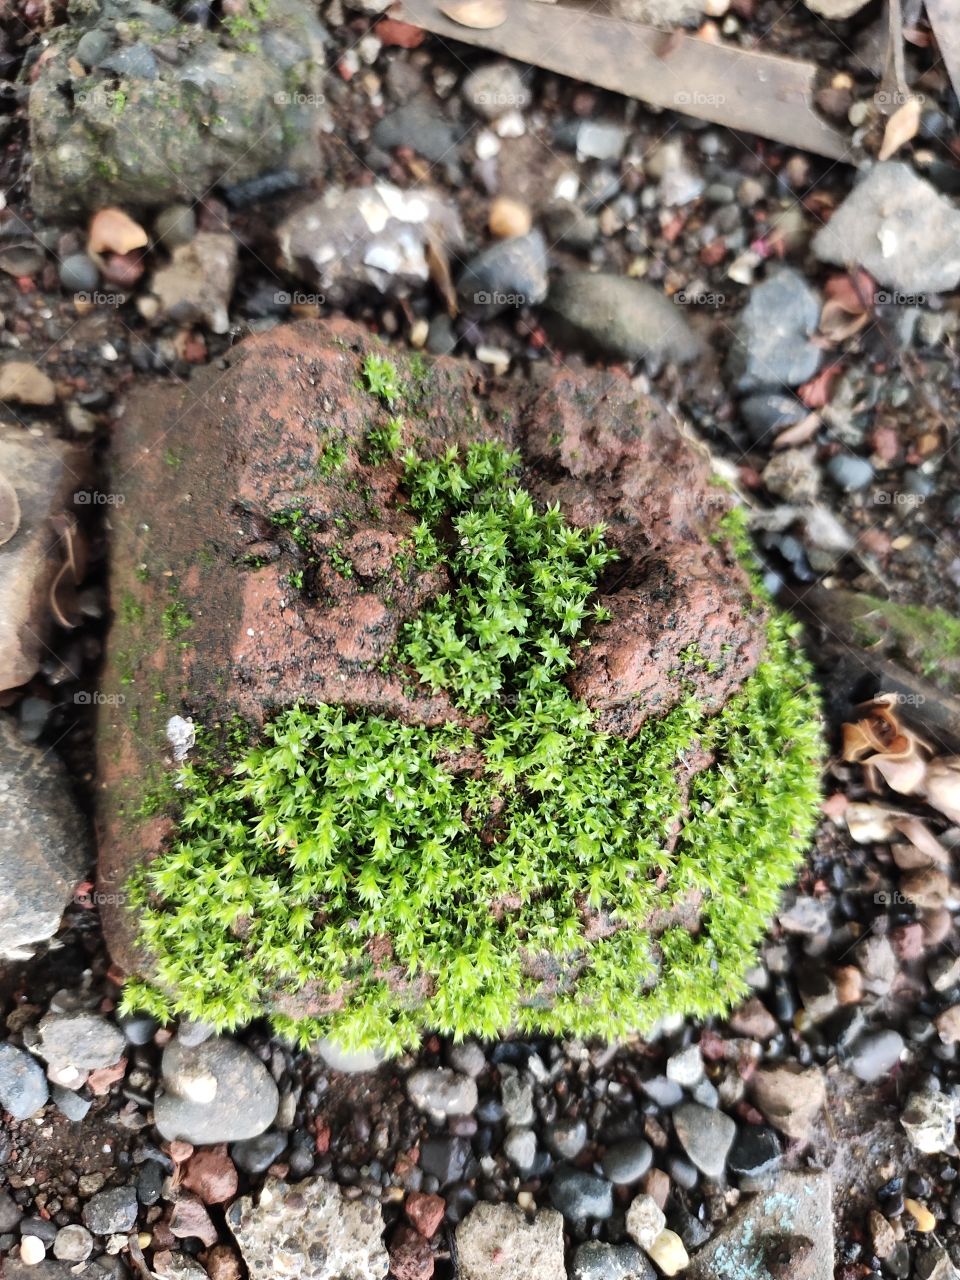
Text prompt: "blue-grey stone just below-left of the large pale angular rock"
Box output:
[[730, 268, 822, 392]]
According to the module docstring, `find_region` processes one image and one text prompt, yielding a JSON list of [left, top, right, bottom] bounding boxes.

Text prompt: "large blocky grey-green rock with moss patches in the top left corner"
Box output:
[[28, 0, 326, 218]]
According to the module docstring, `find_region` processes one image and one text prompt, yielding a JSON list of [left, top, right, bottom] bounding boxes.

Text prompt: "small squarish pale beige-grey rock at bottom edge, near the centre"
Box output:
[[457, 1203, 567, 1280]]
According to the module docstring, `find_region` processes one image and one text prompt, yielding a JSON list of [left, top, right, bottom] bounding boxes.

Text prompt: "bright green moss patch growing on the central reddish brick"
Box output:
[[125, 444, 819, 1050]]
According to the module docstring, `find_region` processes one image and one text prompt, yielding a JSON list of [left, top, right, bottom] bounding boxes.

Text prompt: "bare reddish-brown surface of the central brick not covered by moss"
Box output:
[[99, 321, 764, 1016]]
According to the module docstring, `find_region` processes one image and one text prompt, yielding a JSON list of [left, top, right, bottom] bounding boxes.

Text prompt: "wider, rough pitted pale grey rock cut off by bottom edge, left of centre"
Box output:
[[227, 1178, 389, 1280]]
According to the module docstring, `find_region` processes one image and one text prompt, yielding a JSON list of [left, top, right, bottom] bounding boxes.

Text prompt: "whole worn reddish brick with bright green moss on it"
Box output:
[[100, 314, 818, 1047]]
